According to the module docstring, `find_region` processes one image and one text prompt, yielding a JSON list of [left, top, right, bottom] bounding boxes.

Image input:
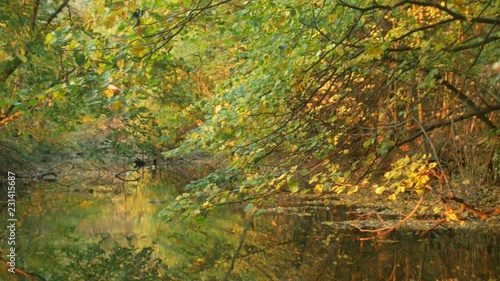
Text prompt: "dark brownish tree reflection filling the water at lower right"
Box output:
[[235, 207, 500, 280]]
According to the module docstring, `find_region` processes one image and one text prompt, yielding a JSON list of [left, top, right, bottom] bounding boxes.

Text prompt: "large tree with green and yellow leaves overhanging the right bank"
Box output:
[[163, 1, 500, 231]]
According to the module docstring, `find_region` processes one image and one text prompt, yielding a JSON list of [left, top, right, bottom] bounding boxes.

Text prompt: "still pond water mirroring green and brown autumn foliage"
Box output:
[[0, 175, 500, 280]]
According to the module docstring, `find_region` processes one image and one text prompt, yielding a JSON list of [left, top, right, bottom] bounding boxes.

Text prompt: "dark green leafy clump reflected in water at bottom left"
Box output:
[[58, 237, 165, 280]]
